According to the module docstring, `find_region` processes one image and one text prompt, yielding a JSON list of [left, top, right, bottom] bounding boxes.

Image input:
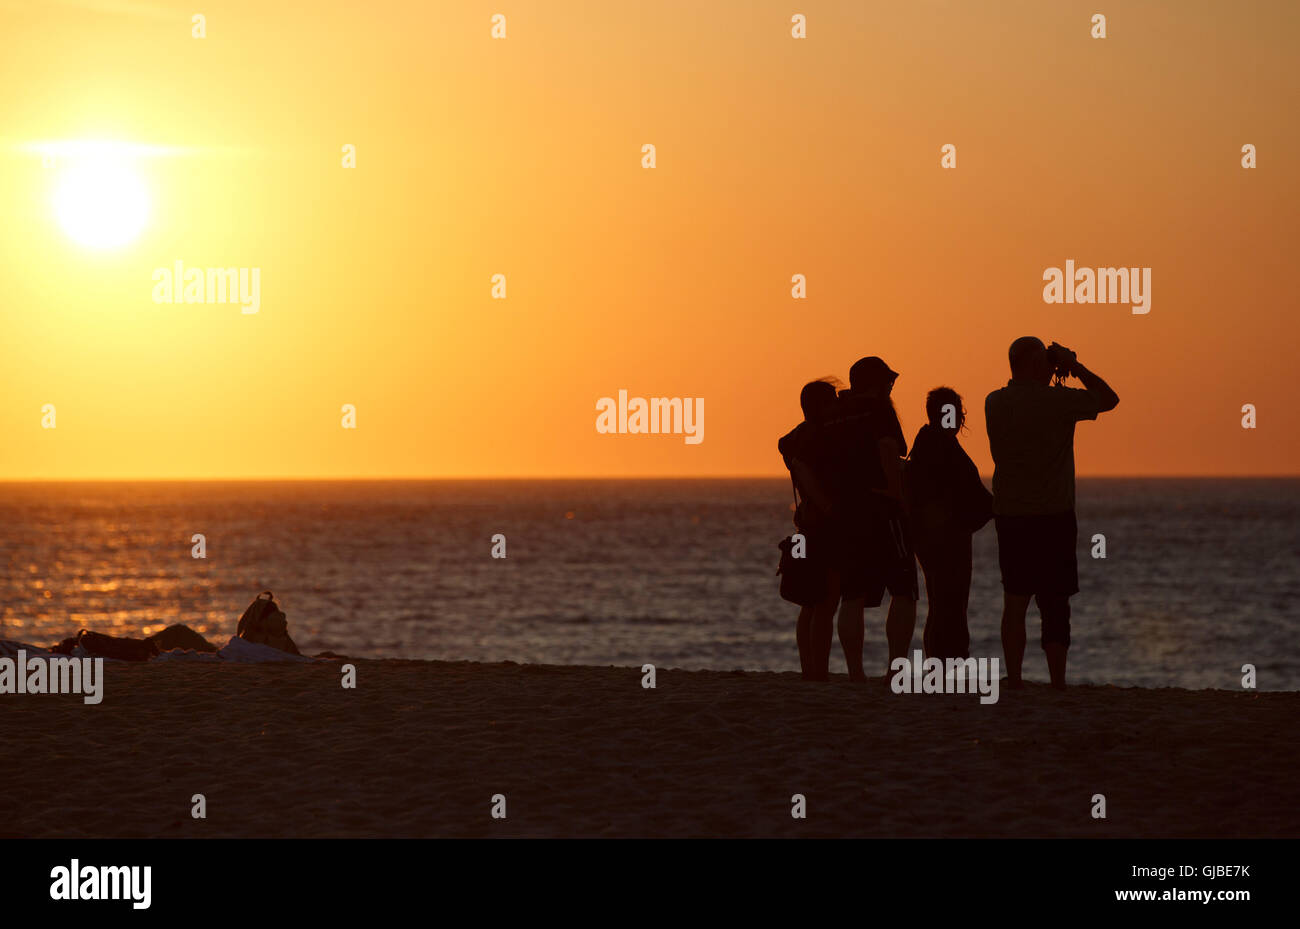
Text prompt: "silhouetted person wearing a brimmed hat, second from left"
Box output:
[[831, 356, 917, 681]]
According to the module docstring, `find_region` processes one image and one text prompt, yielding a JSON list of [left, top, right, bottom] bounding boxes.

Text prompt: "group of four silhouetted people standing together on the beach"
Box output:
[[777, 337, 1119, 687]]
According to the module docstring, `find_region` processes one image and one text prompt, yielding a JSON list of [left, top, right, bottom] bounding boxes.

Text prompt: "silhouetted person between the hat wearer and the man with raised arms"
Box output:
[[904, 387, 993, 659]]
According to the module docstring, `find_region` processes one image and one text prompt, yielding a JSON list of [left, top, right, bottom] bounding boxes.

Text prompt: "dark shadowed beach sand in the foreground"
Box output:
[[0, 660, 1300, 837]]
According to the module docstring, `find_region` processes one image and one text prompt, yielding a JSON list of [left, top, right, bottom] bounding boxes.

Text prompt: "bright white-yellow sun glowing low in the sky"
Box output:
[[53, 143, 150, 249]]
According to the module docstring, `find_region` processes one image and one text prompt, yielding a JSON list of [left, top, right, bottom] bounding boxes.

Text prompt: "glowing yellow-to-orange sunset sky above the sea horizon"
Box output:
[[0, 0, 1300, 479]]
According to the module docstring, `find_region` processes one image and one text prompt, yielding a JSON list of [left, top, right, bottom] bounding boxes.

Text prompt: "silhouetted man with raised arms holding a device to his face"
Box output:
[[984, 335, 1119, 690]]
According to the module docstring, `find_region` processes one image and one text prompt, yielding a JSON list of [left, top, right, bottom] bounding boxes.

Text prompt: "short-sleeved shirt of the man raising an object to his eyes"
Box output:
[[984, 378, 1102, 516]]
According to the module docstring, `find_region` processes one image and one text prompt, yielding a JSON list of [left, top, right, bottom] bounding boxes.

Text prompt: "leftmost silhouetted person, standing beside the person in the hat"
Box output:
[[776, 381, 840, 681]]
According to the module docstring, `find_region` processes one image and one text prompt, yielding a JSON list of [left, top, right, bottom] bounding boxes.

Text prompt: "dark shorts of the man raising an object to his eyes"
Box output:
[[993, 509, 1079, 598]]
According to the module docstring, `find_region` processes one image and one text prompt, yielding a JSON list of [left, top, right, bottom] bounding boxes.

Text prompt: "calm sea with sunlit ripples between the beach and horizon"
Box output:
[[0, 479, 1300, 690]]
